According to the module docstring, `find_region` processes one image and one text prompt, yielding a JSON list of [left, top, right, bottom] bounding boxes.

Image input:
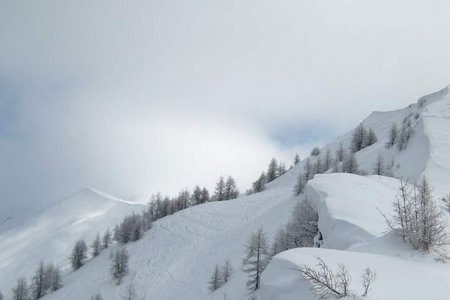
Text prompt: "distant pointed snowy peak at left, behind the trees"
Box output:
[[0, 188, 143, 294]]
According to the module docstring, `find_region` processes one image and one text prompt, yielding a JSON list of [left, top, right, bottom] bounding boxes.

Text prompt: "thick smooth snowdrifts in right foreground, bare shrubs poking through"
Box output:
[[259, 174, 450, 300]]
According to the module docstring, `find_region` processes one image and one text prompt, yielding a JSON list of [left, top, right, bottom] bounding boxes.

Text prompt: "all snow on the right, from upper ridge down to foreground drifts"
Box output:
[[259, 88, 450, 300]]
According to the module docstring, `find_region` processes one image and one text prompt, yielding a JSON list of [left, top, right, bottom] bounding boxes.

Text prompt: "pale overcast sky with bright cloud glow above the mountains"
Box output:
[[0, 0, 450, 216]]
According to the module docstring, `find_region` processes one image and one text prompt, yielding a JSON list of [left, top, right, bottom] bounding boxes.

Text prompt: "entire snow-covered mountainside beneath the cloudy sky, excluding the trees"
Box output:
[[0, 88, 450, 300]]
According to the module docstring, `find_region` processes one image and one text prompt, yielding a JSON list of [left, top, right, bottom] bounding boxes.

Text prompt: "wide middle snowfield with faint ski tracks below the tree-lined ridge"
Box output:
[[41, 170, 297, 300]]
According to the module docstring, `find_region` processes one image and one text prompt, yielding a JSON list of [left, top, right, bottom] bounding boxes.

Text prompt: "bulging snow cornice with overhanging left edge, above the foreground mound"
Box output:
[[306, 174, 399, 249]]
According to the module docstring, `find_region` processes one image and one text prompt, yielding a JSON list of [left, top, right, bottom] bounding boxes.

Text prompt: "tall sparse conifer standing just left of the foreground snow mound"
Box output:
[[243, 228, 270, 291]]
